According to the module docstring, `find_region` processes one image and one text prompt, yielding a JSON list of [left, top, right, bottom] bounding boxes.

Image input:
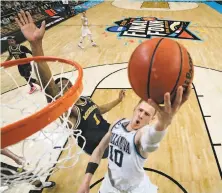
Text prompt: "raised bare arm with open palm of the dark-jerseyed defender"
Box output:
[[15, 10, 58, 102]]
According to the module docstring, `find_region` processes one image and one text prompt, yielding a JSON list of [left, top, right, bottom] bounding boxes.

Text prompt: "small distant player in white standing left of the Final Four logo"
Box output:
[[78, 11, 97, 49]]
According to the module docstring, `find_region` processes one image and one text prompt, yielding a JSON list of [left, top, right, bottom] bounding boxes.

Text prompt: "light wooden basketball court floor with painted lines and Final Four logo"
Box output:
[[1, 0, 222, 193]]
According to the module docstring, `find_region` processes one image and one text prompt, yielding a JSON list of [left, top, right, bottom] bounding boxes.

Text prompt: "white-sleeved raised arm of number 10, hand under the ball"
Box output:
[[135, 86, 191, 157]]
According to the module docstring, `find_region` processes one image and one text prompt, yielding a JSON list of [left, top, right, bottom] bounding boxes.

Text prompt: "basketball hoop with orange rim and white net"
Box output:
[[1, 56, 85, 186]]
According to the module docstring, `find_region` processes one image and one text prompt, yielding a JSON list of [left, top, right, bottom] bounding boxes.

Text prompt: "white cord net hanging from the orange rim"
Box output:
[[0, 61, 85, 186]]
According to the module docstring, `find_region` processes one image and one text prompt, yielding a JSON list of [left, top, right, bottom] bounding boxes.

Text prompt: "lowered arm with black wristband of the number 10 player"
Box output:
[[77, 126, 112, 193]]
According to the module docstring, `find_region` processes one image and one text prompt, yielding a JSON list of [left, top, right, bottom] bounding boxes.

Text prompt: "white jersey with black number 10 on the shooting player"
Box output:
[[108, 119, 146, 191]]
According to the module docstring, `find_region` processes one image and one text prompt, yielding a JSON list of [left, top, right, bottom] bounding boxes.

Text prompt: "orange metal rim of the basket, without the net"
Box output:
[[1, 56, 83, 148]]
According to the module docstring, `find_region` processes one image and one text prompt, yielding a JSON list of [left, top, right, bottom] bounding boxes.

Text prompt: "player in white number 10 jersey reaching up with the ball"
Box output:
[[78, 86, 191, 193]]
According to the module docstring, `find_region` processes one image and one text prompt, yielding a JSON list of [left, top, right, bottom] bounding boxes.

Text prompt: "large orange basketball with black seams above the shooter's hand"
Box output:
[[128, 38, 194, 104]]
